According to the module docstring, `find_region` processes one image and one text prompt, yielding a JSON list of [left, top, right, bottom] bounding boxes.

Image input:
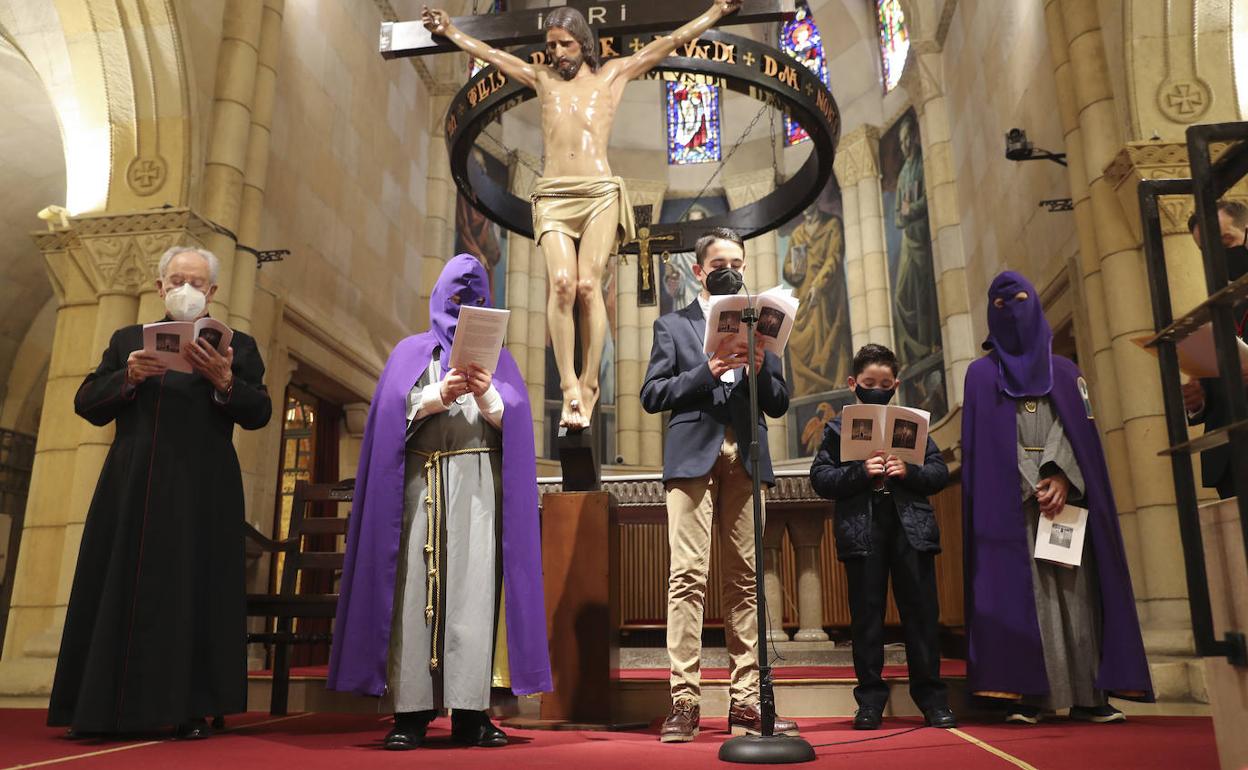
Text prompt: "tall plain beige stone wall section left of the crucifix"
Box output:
[[260, 2, 431, 356]]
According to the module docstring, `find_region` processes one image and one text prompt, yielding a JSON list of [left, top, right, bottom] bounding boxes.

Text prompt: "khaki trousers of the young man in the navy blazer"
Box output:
[[666, 428, 759, 704]]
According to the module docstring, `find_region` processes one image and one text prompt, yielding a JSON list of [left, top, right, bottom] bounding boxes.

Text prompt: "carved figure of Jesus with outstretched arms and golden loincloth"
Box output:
[[421, 0, 741, 431]]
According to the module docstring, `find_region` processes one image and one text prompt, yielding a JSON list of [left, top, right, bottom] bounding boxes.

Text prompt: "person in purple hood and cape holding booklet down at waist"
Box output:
[[962, 271, 1153, 725]]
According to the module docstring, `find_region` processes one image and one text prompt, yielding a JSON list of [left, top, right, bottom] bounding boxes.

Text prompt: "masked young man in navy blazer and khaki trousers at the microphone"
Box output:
[[641, 228, 797, 743]]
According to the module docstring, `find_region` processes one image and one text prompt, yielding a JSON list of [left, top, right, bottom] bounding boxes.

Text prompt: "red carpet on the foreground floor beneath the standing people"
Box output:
[[0, 710, 1218, 770]]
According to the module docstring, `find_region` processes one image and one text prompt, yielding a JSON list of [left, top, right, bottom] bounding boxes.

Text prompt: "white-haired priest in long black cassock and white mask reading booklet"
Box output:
[[47, 247, 272, 738]]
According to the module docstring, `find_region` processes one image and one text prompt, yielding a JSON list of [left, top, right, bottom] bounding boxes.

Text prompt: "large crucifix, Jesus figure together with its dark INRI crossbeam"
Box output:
[[406, 0, 792, 431]]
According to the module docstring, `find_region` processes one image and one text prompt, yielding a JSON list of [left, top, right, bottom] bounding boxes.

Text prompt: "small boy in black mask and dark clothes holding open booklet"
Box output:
[[810, 344, 957, 730]]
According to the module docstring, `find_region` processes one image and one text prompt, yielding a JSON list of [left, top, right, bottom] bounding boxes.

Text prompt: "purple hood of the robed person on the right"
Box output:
[[983, 270, 1053, 398]]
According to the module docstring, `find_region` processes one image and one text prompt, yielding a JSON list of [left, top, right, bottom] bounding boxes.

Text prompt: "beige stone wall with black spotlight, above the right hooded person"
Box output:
[[938, 0, 1078, 346]]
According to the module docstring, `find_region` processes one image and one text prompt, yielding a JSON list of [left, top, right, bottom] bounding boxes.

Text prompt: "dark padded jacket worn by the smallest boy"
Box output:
[[810, 417, 948, 562]]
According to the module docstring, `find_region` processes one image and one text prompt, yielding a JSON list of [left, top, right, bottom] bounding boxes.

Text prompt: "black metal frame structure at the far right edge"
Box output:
[[1138, 122, 1248, 666]]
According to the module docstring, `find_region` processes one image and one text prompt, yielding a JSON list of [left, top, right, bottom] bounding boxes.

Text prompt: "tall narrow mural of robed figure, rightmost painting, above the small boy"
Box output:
[[880, 107, 948, 421]]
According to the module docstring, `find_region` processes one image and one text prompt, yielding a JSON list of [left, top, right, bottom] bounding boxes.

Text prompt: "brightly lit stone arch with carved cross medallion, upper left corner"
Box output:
[[0, 0, 195, 215]]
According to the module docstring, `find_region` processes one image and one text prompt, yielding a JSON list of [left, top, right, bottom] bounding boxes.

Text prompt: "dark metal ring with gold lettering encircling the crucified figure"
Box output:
[[444, 30, 841, 251]]
